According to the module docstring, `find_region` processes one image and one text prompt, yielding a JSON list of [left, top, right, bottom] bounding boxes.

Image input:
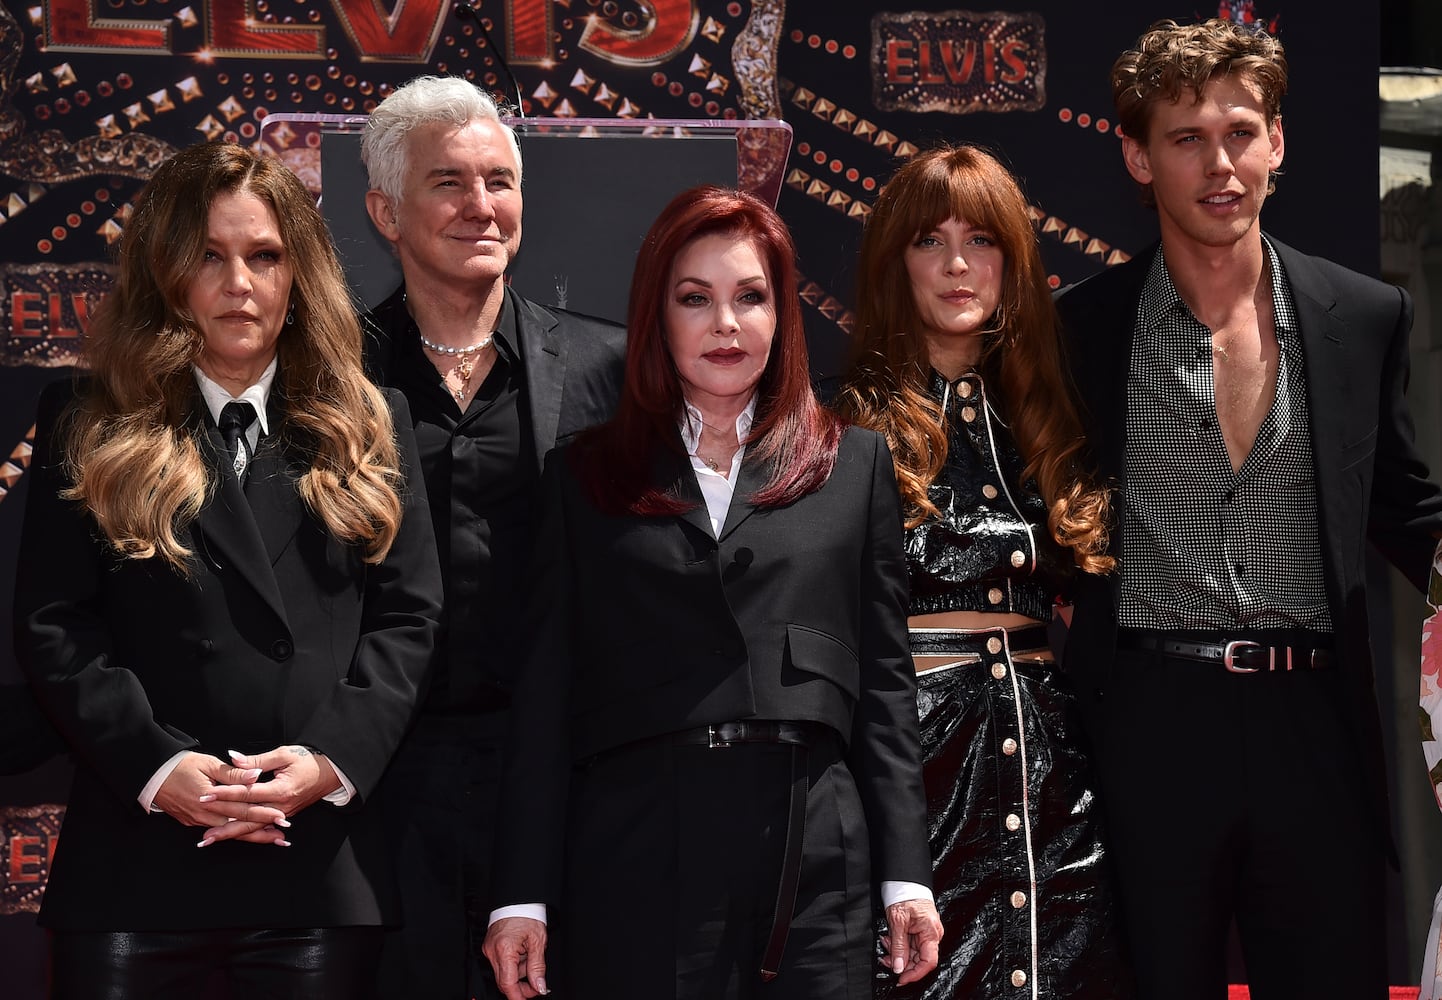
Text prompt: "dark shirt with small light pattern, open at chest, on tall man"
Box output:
[[1119, 244, 1344, 632]]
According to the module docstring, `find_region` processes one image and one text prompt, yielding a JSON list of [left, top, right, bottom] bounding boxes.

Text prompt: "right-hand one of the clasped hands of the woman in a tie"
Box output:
[[200, 746, 340, 846]]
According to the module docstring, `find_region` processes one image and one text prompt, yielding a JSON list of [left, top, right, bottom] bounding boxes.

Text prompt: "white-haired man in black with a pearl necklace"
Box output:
[[361, 76, 624, 1000]]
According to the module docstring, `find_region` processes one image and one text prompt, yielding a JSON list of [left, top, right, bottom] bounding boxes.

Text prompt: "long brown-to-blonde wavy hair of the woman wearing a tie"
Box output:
[[61, 143, 401, 574]]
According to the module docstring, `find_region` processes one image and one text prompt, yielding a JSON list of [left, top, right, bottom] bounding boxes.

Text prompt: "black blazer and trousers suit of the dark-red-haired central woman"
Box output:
[[495, 430, 930, 1000]]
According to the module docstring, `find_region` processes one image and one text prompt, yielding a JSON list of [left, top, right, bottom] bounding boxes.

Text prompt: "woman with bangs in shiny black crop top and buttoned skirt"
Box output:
[[836, 146, 1122, 999]]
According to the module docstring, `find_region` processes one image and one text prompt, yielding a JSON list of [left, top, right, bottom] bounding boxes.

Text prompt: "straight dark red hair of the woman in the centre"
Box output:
[[572, 185, 842, 515]]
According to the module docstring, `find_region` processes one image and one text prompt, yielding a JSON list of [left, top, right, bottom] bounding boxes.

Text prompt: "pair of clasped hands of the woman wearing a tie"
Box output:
[[154, 746, 340, 847]]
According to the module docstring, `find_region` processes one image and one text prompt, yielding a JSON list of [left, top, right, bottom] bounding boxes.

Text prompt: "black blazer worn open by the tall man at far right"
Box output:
[[1057, 237, 1442, 823]]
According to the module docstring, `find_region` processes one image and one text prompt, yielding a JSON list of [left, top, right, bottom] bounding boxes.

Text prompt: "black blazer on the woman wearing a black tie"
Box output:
[[14, 382, 441, 931]]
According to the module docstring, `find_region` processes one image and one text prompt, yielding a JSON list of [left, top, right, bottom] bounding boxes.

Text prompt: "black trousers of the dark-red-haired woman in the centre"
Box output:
[[548, 730, 875, 1000]]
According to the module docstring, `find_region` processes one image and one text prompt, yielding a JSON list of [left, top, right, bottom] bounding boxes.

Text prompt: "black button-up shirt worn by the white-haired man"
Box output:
[[366, 286, 539, 714]]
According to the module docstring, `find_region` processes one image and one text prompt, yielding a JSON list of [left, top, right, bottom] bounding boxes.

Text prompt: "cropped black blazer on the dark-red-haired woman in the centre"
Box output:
[[492, 429, 932, 906]]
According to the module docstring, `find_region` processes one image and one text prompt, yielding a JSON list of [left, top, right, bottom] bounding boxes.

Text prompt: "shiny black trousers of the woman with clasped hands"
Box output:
[[50, 923, 382, 1000]]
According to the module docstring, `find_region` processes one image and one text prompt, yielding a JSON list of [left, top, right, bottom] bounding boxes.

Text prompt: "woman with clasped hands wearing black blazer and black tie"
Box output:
[[14, 143, 440, 1000]]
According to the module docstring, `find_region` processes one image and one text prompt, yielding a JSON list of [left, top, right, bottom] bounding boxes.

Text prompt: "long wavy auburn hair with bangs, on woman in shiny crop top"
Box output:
[[836, 146, 1115, 573]]
